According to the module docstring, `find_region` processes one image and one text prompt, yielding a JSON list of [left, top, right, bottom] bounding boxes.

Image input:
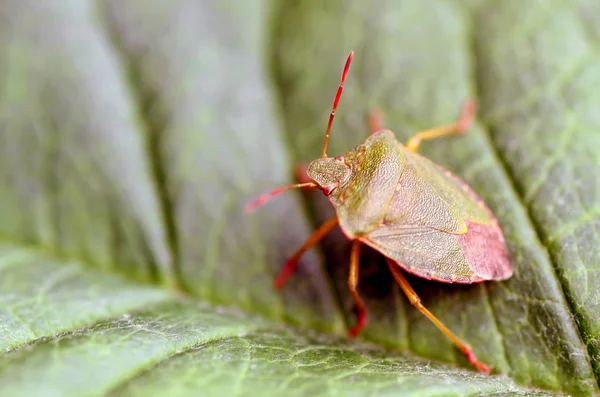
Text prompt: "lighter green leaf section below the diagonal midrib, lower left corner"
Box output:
[[0, 245, 551, 396]]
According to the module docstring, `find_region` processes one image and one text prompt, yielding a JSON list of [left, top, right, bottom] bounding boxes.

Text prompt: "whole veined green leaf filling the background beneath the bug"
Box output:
[[0, 0, 600, 396]]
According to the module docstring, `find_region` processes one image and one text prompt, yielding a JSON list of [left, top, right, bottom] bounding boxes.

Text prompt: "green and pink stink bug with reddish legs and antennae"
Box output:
[[246, 52, 512, 373]]
